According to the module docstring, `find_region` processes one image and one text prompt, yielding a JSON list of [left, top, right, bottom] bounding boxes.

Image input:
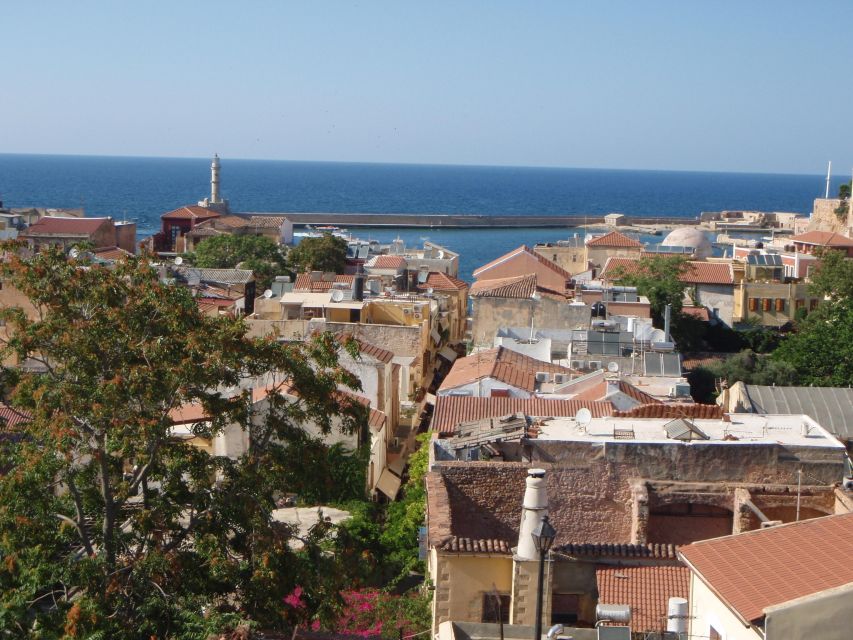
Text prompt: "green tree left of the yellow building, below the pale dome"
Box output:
[[612, 255, 688, 326]]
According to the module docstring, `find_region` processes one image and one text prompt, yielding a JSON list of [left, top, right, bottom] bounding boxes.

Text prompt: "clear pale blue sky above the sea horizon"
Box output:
[[6, 0, 853, 173]]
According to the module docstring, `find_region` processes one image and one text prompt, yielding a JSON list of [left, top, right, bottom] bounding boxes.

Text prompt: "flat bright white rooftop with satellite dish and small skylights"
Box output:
[[538, 413, 844, 450]]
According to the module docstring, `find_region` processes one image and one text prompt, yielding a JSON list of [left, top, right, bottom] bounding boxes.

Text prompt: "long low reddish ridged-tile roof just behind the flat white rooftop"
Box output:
[[430, 396, 614, 433]]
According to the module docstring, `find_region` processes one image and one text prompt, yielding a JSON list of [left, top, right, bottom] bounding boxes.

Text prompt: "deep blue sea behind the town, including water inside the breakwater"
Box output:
[[0, 154, 843, 279]]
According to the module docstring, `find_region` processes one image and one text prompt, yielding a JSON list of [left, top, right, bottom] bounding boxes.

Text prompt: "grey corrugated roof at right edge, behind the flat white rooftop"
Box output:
[[732, 384, 853, 440]]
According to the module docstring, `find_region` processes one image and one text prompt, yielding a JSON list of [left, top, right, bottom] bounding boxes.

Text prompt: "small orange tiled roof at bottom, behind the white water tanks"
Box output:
[[595, 565, 690, 631]]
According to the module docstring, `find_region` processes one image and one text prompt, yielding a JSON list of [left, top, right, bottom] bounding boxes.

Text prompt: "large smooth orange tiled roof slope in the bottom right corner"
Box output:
[[679, 513, 853, 623]]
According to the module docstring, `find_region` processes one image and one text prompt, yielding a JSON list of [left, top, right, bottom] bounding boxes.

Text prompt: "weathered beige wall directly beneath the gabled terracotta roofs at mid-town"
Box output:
[[471, 297, 590, 346]]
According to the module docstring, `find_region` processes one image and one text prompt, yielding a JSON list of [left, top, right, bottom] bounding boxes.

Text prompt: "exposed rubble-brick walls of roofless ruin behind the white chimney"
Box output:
[[426, 462, 631, 553]]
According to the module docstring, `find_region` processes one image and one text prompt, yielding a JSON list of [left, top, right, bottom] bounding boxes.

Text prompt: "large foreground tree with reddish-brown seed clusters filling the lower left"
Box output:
[[0, 246, 366, 639]]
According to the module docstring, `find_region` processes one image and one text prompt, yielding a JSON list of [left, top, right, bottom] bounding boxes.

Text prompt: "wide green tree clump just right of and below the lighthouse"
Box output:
[[191, 235, 288, 289]]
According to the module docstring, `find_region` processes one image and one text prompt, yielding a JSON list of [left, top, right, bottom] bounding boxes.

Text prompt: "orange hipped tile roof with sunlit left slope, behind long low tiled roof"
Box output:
[[439, 347, 575, 393]]
